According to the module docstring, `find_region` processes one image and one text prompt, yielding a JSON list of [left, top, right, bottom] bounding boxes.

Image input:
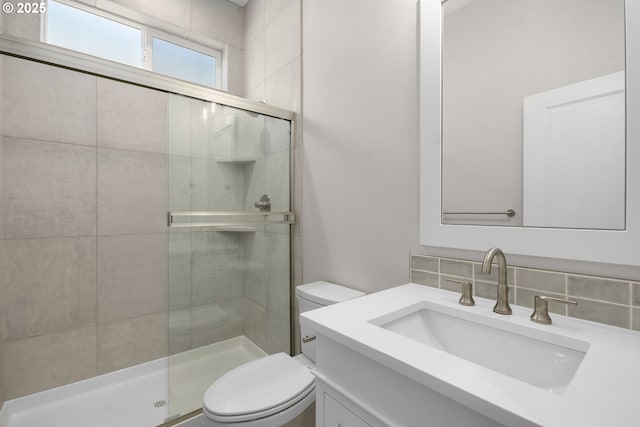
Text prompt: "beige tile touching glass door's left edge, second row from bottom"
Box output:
[[98, 234, 167, 324]]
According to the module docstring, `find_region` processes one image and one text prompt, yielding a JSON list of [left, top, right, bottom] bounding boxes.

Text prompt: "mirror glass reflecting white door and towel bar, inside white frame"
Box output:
[[442, 0, 625, 230]]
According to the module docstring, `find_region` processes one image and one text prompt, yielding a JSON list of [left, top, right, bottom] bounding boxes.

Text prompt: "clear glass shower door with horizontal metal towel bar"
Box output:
[[167, 95, 294, 418]]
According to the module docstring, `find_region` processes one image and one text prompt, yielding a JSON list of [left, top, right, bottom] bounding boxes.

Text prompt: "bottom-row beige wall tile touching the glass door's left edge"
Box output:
[[98, 313, 167, 374]]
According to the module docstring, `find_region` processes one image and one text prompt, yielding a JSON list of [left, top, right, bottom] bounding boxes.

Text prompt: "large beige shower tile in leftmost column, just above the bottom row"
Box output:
[[0, 237, 96, 340]]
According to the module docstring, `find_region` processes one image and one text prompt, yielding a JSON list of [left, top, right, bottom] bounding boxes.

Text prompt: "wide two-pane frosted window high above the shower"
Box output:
[[43, 0, 222, 89]]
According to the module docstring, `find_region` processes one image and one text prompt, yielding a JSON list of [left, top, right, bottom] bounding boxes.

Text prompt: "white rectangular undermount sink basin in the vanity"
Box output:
[[370, 302, 589, 394]]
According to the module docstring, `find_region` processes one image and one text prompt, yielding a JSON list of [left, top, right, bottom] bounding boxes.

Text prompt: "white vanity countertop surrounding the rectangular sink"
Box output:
[[301, 284, 640, 427]]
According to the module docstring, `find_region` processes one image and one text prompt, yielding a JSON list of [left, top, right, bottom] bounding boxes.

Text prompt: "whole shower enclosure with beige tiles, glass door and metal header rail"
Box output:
[[0, 40, 295, 427]]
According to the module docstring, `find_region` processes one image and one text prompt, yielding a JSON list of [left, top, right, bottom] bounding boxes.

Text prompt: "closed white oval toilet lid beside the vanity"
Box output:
[[203, 353, 314, 421]]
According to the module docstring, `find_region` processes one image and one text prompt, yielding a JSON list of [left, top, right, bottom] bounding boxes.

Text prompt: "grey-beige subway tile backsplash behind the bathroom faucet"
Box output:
[[410, 254, 640, 331]]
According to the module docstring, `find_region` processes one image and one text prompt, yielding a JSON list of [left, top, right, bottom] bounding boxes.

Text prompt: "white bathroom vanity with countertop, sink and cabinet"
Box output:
[[301, 284, 640, 427]]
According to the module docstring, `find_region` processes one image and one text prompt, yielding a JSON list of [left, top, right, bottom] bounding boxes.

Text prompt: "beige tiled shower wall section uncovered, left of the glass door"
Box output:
[[0, 57, 167, 399]]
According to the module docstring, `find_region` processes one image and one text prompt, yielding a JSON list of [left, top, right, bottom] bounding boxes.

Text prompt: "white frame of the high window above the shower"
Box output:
[[40, 0, 224, 90]]
